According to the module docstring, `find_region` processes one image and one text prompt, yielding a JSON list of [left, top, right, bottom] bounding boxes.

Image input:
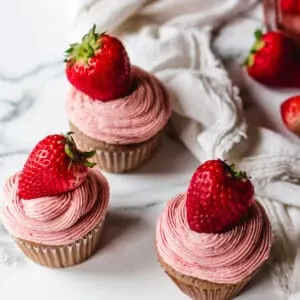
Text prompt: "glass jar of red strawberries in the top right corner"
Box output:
[[263, 0, 300, 45]]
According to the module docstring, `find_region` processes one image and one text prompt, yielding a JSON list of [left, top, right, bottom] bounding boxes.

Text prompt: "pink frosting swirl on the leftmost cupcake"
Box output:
[[1, 170, 109, 245]]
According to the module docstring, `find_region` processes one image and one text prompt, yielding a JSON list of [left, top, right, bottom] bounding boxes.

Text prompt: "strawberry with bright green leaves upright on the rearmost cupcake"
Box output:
[[65, 25, 132, 101]]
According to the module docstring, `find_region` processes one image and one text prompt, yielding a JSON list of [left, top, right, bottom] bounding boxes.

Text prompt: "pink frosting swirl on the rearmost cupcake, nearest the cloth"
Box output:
[[66, 67, 171, 145]]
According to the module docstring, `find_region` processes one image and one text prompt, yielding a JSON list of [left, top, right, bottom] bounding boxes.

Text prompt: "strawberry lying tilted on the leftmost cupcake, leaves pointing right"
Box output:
[[18, 133, 95, 199]]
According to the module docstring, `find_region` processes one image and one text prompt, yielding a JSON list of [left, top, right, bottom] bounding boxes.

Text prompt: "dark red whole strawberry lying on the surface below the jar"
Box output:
[[245, 30, 300, 87]]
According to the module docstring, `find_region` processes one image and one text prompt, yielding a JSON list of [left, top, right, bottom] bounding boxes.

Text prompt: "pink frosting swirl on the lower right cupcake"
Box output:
[[156, 194, 272, 284]]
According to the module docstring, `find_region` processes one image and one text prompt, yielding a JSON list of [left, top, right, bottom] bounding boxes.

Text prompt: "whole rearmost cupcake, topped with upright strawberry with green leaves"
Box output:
[[66, 27, 171, 173]]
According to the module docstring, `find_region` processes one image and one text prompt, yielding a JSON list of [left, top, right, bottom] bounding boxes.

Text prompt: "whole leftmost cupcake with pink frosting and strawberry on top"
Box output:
[[1, 134, 109, 268]]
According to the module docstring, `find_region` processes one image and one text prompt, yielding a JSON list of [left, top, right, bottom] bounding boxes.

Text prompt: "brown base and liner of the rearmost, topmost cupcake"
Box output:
[[70, 123, 161, 173]]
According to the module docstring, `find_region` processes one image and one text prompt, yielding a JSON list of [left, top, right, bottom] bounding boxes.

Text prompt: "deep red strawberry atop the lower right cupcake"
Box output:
[[186, 160, 254, 233]]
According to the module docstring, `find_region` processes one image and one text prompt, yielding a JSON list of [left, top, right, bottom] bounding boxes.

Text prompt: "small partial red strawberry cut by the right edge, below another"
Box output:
[[280, 96, 300, 135]]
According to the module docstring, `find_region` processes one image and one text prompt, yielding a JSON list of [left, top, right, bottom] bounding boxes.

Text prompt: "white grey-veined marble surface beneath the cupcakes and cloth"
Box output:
[[0, 0, 292, 300]]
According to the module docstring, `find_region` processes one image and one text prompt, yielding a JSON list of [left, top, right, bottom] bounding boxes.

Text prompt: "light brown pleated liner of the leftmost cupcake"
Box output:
[[15, 220, 104, 268]]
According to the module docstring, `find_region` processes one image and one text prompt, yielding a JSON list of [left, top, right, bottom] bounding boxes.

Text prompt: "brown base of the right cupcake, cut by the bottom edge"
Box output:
[[158, 257, 255, 300]]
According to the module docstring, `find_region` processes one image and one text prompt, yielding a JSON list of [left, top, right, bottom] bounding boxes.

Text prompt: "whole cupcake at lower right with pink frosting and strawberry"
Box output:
[[156, 160, 272, 300]]
